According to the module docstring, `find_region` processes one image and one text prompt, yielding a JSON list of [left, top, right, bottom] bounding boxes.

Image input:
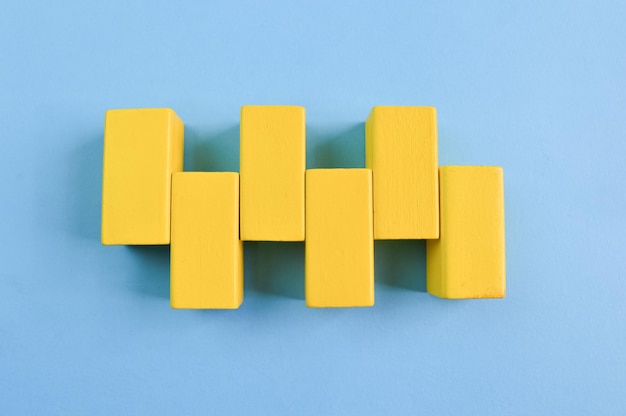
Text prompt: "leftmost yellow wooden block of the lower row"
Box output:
[[170, 172, 243, 309]]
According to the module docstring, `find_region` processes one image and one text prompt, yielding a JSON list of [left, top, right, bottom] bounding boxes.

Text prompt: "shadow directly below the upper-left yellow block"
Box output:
[[127, 245, 170, 299]]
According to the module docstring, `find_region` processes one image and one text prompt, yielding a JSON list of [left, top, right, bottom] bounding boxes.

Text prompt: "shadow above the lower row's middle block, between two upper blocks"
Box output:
[[306, 123, 365, 169]]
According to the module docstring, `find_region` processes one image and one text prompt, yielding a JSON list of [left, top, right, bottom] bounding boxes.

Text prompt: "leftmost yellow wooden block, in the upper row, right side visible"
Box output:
[[102, 108, 184, 245]]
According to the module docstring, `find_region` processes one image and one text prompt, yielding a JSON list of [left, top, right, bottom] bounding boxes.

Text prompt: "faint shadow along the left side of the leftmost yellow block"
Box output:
[[67, 135, 104, 241]]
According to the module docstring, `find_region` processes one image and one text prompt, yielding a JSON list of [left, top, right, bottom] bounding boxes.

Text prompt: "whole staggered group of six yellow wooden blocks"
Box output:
[[102, 106, 505, 309]]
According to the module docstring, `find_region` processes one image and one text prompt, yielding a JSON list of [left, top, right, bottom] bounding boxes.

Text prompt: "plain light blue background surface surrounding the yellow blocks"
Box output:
[[0, 0, 626, 415]]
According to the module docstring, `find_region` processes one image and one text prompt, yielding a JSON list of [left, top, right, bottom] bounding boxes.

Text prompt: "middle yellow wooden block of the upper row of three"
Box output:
[[240, 106, 306, 241]]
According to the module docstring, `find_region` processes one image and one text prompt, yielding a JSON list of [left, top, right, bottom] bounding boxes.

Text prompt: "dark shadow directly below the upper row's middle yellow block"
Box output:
[[244, 241, 304, 299]]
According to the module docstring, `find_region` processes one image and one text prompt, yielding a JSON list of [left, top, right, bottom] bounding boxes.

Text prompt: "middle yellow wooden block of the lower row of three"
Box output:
[[305, 169, 374, 308]]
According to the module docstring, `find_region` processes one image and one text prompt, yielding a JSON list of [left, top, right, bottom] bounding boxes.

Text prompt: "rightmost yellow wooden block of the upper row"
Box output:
[[365, 106, 439, 240]]
